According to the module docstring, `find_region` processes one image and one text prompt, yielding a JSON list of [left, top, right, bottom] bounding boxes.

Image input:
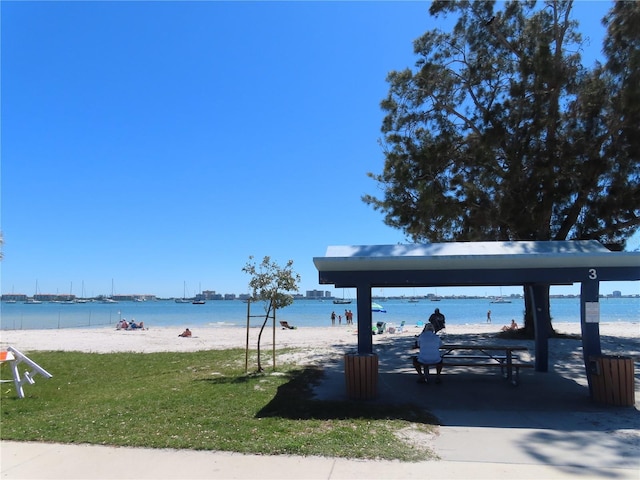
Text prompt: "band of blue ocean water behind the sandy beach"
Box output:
[[0, 297, 640, 330]]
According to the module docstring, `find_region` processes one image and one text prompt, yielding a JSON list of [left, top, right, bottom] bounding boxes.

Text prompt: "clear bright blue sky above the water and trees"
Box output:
[[0, 1, 640, 297]]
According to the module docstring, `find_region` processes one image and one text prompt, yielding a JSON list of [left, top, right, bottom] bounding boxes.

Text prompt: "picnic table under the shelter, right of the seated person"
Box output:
[[440, 343, 533, 385]]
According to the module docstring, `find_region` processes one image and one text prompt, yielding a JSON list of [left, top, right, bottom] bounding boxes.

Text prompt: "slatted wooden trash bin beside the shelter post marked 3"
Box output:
[[589, 355, 635, 407]]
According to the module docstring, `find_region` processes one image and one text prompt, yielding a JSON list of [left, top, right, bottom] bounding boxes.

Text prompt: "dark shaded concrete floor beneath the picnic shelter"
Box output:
[[314, 334, 640, 428]]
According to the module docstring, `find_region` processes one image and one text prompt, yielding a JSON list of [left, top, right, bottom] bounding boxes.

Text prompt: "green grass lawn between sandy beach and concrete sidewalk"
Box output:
[[0, 350, 434, 461]]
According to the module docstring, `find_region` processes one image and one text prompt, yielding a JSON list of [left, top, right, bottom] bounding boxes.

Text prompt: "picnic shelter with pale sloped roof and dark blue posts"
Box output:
[[313, 240, 640, 400]]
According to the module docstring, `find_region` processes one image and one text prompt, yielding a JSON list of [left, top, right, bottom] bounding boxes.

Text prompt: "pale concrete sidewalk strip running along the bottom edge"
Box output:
[[0, 438, 639, 480]]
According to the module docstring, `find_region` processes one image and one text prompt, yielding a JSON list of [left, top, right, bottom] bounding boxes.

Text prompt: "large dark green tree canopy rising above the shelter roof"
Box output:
[[363, 0, 640, 250]]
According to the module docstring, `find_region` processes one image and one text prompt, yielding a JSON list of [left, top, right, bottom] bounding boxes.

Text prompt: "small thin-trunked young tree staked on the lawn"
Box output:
[[242, 256, 300, 372]]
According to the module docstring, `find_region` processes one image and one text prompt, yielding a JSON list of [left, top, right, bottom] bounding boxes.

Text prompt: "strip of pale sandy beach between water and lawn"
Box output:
[[0, 322, 640, 361]]
